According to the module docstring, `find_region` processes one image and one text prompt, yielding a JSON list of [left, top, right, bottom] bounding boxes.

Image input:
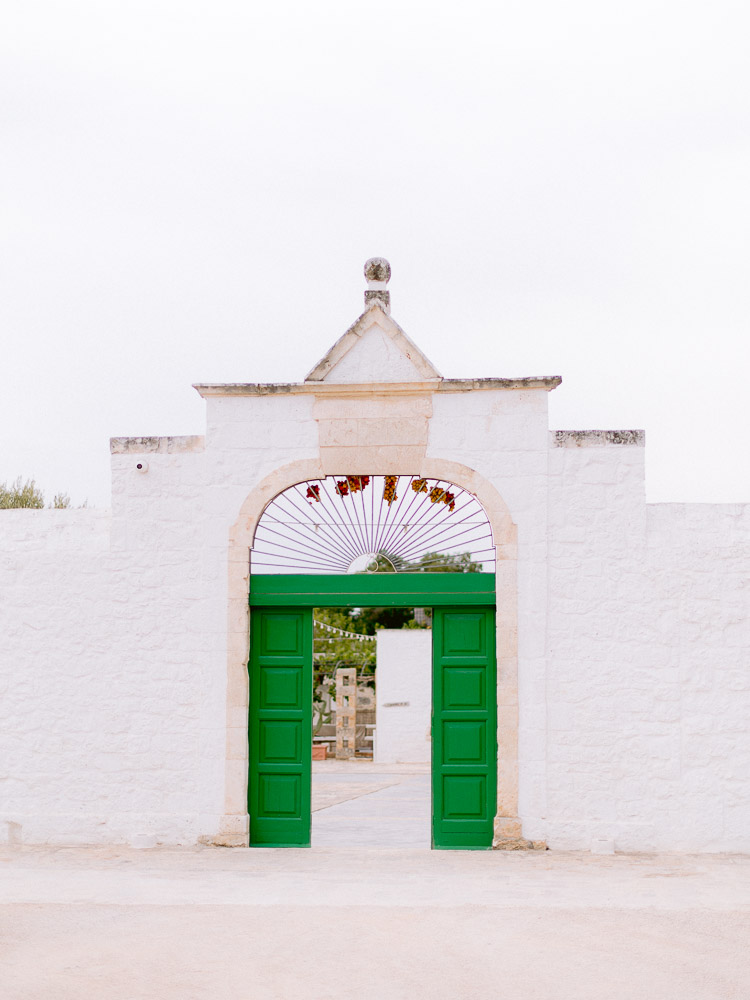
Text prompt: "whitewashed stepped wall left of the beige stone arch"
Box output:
[[0, 397, 317, 843]]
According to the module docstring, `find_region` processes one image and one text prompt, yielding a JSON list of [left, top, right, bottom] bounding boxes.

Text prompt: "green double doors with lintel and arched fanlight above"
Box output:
[[248, 475, 497, 848]]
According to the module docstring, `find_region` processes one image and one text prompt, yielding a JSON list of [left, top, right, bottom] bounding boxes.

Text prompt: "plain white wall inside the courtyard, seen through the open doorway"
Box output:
[[375, 629, 432, 764]]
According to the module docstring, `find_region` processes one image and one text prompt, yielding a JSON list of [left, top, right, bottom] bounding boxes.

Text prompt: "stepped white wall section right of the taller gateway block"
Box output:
[[548, 442, 750, 851]]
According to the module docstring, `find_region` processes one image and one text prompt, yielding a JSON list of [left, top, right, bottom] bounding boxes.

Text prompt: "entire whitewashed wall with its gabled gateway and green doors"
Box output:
[[0, 260, 750, 851]]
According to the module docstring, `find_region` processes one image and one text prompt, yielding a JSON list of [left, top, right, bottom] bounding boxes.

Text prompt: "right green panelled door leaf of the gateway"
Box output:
[[432, 607, 497, 849]]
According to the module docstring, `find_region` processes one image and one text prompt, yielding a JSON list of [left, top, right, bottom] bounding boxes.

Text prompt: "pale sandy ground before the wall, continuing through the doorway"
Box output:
[[0, 771, 750, 1000]]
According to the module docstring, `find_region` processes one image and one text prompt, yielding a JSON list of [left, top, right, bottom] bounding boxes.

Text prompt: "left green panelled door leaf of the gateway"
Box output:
[[248, 608, 312, 847]]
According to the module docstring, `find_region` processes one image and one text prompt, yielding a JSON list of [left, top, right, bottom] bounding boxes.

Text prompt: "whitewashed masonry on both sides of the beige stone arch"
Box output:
[[0, 390, 750, 851]]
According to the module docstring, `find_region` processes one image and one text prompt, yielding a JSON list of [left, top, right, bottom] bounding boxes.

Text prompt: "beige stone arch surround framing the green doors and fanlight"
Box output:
[[213, 456, 521, 847]]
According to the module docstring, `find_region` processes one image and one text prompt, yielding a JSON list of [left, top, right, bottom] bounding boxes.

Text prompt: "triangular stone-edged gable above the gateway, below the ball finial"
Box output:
[[305, 299, 442, 383]]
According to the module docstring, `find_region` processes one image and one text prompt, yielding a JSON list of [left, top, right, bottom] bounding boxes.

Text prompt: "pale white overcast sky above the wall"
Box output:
[[0, 0, 750, 506]]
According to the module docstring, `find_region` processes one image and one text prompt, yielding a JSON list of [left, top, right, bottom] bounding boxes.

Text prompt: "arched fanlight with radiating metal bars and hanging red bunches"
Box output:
[[251, 476, 495, 573]]
